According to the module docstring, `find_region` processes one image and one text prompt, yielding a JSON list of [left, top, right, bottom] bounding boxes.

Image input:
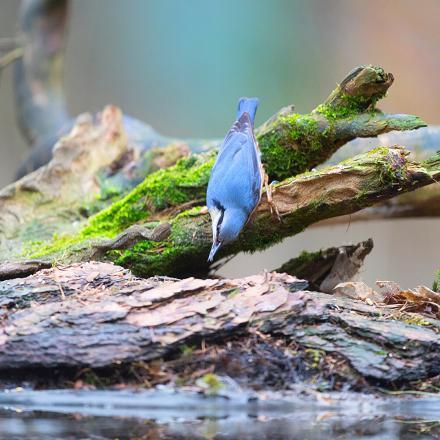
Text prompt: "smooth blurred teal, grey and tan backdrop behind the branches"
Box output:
[[0, 0, 440, 284]]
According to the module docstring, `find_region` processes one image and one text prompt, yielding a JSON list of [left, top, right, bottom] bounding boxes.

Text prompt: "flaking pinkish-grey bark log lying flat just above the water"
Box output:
[[0, 263, 440, 386]]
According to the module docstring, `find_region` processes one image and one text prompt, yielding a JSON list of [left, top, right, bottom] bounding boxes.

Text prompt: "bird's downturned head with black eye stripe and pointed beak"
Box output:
[[208, 206, 247, 262]]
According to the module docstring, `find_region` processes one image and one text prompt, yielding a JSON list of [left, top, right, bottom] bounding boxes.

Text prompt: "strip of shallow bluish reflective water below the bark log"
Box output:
[[0, 390, 440, 440]]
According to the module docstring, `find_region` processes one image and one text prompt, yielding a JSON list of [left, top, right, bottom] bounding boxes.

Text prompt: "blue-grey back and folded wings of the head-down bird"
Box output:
[[208, 113, 262, 214]]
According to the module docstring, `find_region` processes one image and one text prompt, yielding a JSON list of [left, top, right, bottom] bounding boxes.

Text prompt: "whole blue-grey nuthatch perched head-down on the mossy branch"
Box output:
[[206, 98, 263, 261]]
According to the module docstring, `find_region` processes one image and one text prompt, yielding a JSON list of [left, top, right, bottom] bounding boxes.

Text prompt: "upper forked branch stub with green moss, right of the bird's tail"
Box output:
[[257, 66, 426, 180]]
